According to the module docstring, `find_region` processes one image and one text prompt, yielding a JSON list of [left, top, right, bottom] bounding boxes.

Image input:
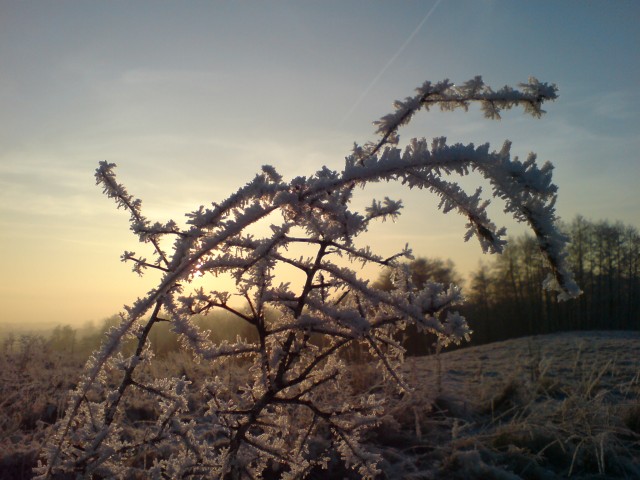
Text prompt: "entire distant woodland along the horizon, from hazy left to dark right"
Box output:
[[7, 216, 640, 358]]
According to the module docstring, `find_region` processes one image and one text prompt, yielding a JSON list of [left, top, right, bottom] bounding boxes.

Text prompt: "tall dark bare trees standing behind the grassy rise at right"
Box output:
[[465, 216, 640, 344]]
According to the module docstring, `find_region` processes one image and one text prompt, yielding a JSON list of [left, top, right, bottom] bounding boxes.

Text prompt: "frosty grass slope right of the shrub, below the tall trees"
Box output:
[[362, 332, 640, 479]]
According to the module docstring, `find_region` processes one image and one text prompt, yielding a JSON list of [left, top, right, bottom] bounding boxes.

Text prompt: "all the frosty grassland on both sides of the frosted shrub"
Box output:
[[0, 332, 640, 479]]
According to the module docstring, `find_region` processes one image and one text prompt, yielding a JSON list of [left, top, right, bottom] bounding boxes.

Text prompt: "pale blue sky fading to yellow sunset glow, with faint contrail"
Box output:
[[0, 0, 640, 328]]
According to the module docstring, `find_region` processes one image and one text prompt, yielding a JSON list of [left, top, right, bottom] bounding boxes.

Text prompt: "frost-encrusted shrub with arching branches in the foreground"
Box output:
[[37, 77, 579, 478]]
